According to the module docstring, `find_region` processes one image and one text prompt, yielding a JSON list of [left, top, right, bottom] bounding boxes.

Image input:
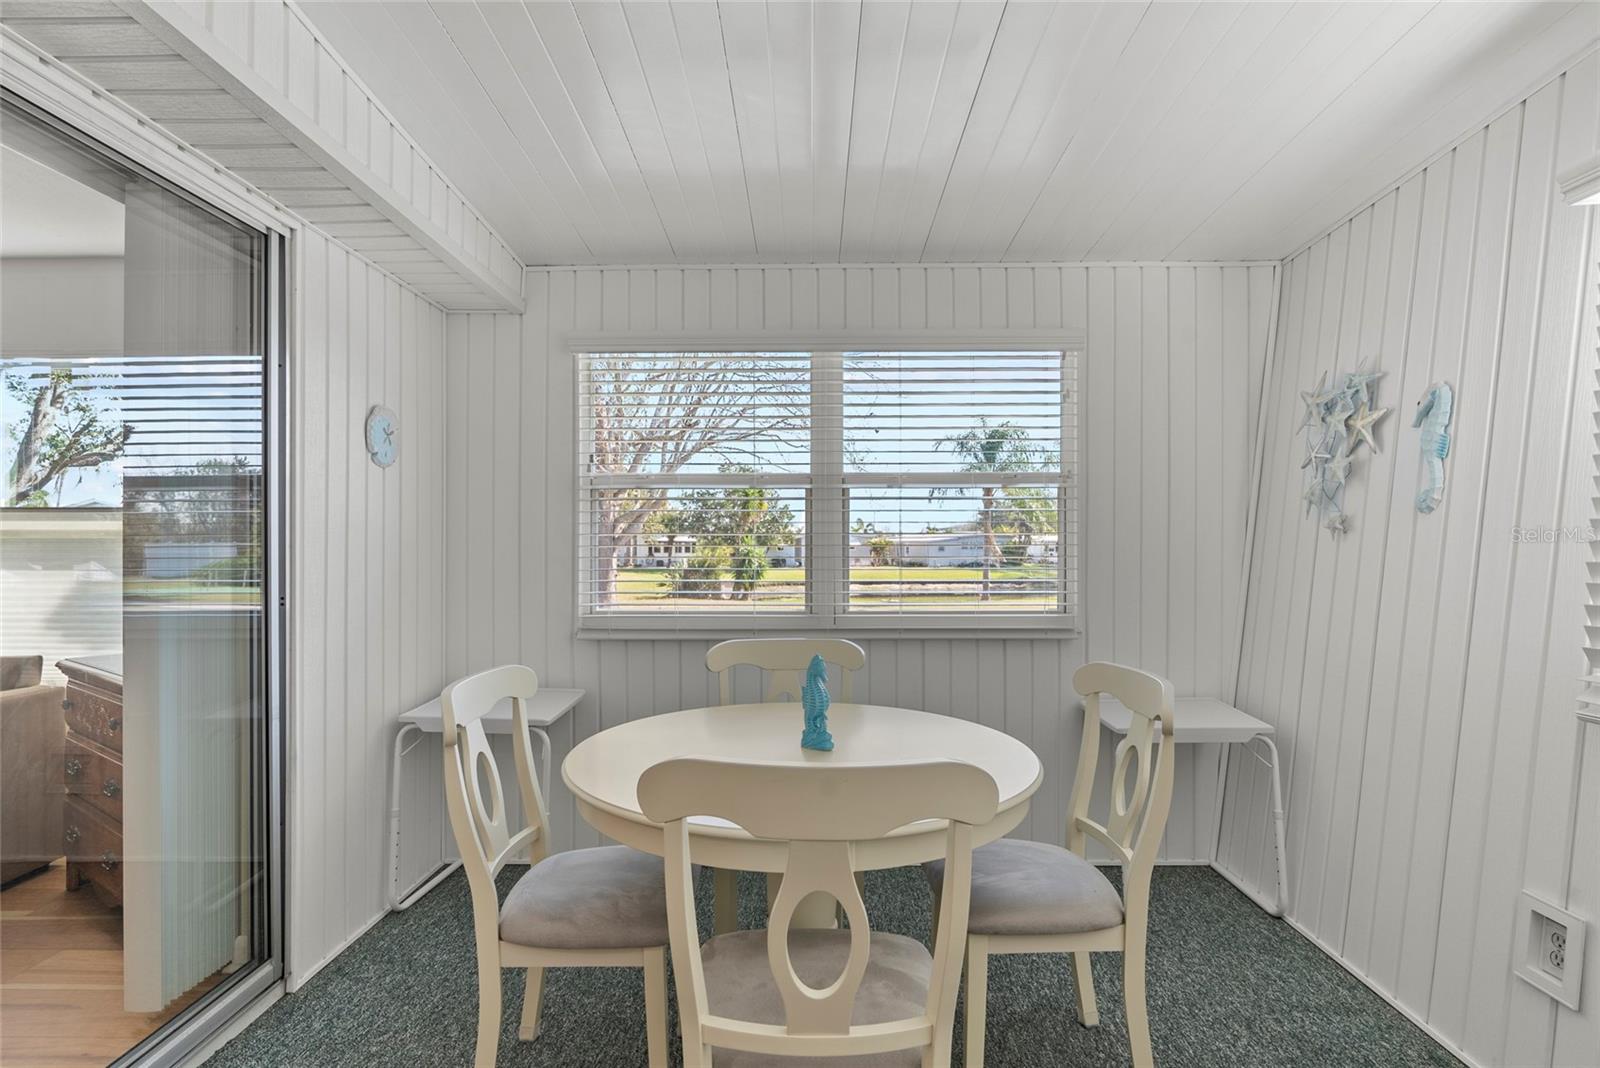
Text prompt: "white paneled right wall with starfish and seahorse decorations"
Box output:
[[1228, 56, 1600, 1065]]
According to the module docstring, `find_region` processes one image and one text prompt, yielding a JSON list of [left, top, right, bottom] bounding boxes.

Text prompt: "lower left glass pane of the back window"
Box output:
[[581, 486, 806, 614]]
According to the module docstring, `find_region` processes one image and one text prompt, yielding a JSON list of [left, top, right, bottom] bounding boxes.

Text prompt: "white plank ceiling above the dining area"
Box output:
[[294, 0, 1600, 264]]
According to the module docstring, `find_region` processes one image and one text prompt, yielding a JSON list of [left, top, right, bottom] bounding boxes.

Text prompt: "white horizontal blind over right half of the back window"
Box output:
[[835, 352, 1075, 616]]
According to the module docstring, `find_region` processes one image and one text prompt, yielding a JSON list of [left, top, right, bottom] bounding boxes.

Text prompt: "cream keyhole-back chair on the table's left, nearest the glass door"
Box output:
[[440, 665, 667, 1068]]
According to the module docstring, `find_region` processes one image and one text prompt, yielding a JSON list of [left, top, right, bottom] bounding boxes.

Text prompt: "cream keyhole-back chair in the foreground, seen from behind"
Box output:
[[638, 758, 998, 1068]]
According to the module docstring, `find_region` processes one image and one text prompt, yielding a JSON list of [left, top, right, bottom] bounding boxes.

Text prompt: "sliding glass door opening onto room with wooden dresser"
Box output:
[[0, 98, 282, 1065]]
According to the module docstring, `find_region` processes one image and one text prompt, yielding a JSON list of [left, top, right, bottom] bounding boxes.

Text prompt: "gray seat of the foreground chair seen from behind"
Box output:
[[701, 929, 933, 1068]]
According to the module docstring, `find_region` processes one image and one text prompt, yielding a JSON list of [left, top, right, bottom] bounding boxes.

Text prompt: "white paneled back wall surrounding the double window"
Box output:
[[445, 264, 1274, 860]]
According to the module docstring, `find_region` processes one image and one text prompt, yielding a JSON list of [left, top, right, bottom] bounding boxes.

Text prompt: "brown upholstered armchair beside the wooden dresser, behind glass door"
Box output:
[[0, 657, 66, 883]]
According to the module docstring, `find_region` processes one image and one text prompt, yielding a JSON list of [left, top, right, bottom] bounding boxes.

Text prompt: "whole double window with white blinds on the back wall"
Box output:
[[578, 349, 1078, 628]]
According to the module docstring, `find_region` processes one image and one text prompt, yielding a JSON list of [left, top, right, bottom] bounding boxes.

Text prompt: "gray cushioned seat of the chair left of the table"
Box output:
[[501, 846, 667, 950]]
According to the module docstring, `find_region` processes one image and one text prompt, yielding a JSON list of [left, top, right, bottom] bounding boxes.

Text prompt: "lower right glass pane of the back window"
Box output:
[[845, 486, 1062, 612]]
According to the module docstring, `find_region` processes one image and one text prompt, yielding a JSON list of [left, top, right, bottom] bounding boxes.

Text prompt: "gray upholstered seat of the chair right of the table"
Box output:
[[922, 838, 1122, 935]]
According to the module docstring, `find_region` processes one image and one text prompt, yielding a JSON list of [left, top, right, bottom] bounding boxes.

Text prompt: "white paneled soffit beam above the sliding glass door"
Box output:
[[3, 0, 522, 309]]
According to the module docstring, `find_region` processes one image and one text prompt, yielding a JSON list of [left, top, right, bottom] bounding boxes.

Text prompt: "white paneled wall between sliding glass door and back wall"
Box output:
[[288, 229, 445, 985]]
